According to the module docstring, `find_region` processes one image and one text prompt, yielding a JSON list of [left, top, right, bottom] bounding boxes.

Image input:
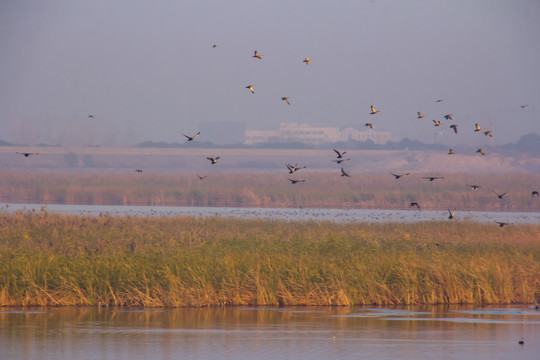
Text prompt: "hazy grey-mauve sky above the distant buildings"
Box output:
[[0, 0, 540, 145]]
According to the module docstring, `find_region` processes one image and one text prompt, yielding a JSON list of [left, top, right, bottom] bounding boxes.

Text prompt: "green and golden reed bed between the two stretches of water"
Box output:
[[0, 213, 540, 307]]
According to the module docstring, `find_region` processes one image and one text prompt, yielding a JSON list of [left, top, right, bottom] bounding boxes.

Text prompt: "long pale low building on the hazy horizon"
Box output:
[[245, 123, 390, 145]]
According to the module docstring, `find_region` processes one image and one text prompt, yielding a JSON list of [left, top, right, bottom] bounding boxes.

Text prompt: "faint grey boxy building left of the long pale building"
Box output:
[[197, 121, 246, 145]]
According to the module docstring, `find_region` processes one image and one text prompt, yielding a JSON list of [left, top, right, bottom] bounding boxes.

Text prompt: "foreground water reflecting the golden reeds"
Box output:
[[0, 306, 540, 360]]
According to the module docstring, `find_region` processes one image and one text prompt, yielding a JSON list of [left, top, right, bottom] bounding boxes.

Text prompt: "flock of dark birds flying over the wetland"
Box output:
[[13, 44, 540, 227]]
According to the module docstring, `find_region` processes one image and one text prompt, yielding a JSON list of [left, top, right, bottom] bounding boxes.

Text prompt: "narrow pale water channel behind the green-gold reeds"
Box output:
[[0, 204, 540, 224]]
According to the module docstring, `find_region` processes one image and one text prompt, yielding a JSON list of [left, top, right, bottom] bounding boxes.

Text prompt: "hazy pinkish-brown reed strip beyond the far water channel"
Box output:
[[0, 169, 540, 211]]
